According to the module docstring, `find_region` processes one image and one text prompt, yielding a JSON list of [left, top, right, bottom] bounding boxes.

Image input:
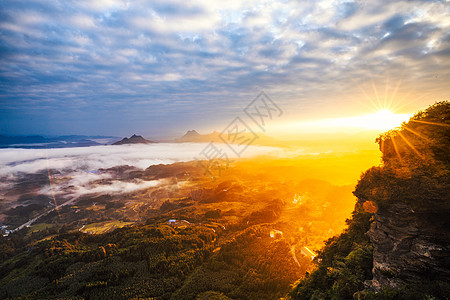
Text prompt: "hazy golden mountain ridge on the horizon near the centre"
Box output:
[[175, 130, 286, 147]]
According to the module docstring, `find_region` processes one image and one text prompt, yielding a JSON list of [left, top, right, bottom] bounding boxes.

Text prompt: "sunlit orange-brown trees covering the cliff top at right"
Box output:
[[354, 101, 450, 212]]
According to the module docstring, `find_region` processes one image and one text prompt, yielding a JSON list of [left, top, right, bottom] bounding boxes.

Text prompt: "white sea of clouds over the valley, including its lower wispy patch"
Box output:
[[0, 143, 282, 198]]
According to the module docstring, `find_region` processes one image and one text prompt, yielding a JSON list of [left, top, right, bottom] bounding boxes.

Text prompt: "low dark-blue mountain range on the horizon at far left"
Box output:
[[0, 135, 117, 149]]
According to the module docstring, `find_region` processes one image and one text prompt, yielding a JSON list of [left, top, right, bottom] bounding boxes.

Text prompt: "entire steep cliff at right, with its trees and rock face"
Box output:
[[290, 102, 450, 299]]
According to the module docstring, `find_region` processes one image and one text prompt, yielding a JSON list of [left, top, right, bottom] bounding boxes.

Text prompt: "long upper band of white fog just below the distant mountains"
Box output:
[[0, 143, 280, 176]]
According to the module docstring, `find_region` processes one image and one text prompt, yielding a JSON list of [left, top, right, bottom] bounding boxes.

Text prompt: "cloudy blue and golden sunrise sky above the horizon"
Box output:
[[0, 0, 450, 138]]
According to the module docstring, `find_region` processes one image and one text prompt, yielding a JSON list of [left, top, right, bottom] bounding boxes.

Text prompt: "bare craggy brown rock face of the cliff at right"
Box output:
[[366, 204, 450, 291]]
